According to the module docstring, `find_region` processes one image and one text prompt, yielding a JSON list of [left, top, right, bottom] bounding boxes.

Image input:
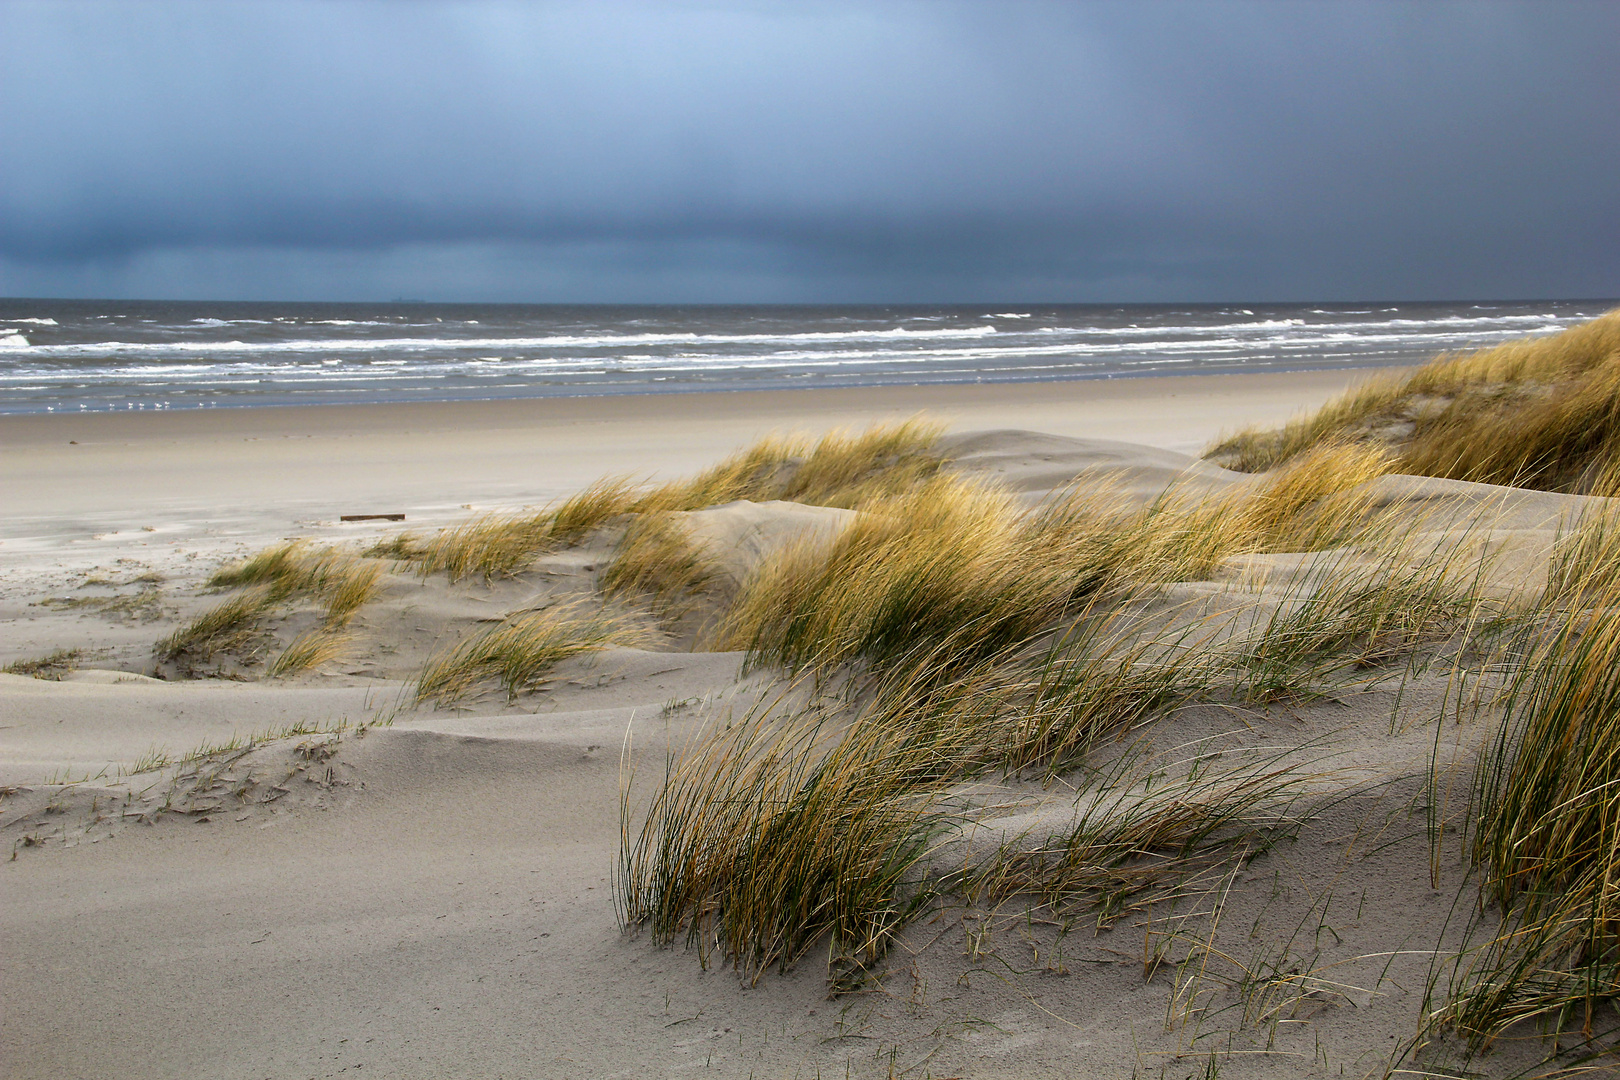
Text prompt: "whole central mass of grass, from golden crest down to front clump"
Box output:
[[619, 447, 1503, 988]]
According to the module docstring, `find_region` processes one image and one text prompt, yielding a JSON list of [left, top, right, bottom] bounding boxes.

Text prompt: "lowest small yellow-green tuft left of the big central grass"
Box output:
[[415, 602, 651, 704]]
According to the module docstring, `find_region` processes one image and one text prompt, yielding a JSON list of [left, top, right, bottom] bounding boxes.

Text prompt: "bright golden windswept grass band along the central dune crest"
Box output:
[[718, 447, 1387, 683]]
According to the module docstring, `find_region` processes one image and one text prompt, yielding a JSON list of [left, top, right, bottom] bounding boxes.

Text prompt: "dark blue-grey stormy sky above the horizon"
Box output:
[[0, 0, 1620, 303]]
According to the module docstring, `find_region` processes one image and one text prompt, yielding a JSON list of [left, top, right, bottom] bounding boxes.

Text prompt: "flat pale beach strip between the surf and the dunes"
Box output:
[[0, 369, 1398, 538]]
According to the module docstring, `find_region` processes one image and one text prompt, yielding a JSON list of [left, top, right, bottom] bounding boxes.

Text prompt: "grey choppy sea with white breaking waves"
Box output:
[[0, 300, 1617, 413]]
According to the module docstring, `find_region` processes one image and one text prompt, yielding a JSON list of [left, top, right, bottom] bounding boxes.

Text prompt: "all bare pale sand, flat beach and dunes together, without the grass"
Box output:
[[0, 372, 1555, 1080]]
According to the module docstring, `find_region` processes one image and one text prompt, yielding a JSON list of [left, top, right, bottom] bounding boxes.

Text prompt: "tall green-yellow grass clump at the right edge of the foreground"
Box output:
[[1430, 517, 1620, 1051]]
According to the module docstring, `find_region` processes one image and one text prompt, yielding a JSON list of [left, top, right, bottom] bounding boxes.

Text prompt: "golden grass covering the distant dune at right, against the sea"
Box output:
[[1210, 311, 1620, 491]]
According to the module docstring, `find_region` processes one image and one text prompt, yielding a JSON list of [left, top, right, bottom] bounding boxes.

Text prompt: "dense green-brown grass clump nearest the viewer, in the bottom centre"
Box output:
[[616, 693, 959, 986]]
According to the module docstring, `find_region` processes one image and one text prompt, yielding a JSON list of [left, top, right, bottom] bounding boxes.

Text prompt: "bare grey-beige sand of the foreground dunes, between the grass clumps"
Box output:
[[0, 375, 1592, 1080]]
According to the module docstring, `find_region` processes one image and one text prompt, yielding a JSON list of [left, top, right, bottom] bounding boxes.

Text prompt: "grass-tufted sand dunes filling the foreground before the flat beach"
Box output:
[[0, 359, 1620, 1077]]
